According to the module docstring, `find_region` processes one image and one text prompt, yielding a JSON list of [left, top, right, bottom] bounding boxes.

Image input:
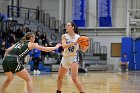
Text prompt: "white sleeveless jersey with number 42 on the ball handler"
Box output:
[[63, 34, 80, 56]]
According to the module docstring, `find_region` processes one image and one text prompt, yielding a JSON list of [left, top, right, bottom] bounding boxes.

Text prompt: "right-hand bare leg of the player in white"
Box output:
[[70, 62, 84, 93]]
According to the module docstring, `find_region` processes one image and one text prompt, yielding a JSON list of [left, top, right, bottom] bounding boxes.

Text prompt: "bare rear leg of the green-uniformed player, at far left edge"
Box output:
[[0, 72, 14, 92]]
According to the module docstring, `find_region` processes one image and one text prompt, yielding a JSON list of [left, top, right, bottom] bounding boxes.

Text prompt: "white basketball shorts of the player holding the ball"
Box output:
[[60, 56, 79, 69]]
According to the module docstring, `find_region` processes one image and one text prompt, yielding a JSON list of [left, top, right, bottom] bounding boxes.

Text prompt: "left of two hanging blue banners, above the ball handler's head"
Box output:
[[72, 0, 86, 27]]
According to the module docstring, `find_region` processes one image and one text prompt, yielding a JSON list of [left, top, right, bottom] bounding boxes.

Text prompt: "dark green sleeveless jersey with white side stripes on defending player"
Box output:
[[8, 41, 30, 60]]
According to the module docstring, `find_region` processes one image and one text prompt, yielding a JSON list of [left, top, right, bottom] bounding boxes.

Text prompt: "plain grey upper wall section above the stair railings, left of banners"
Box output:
[[20, 0, 59, 19]]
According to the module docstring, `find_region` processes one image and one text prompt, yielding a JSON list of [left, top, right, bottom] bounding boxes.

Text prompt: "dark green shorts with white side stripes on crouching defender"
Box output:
[[2, 56, 24, 74]]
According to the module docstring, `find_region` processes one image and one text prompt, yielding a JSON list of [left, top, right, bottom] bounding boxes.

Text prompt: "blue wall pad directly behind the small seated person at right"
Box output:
[[121, 37, 135, 70]]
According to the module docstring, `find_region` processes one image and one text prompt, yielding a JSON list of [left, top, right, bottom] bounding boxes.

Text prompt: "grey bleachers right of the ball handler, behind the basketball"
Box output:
[[81, 39, 110, 71]]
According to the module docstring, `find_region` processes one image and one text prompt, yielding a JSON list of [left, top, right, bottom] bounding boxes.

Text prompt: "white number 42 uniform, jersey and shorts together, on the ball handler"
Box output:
[[61, 33, 80, 69]]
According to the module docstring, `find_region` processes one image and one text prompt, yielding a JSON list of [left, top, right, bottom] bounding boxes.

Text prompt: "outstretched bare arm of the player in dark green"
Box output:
[[28, 42, 61, 52]]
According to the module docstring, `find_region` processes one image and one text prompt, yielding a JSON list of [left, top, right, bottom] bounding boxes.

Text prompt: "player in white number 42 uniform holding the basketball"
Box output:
[[56, 22, 86, 93]]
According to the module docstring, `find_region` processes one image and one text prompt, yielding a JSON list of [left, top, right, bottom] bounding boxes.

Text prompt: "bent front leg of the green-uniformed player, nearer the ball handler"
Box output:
[[16, 68, 33, 93]]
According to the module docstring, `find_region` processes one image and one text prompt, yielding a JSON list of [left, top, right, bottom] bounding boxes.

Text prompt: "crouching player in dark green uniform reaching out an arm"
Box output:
[[0, 32, 61, 93]]
